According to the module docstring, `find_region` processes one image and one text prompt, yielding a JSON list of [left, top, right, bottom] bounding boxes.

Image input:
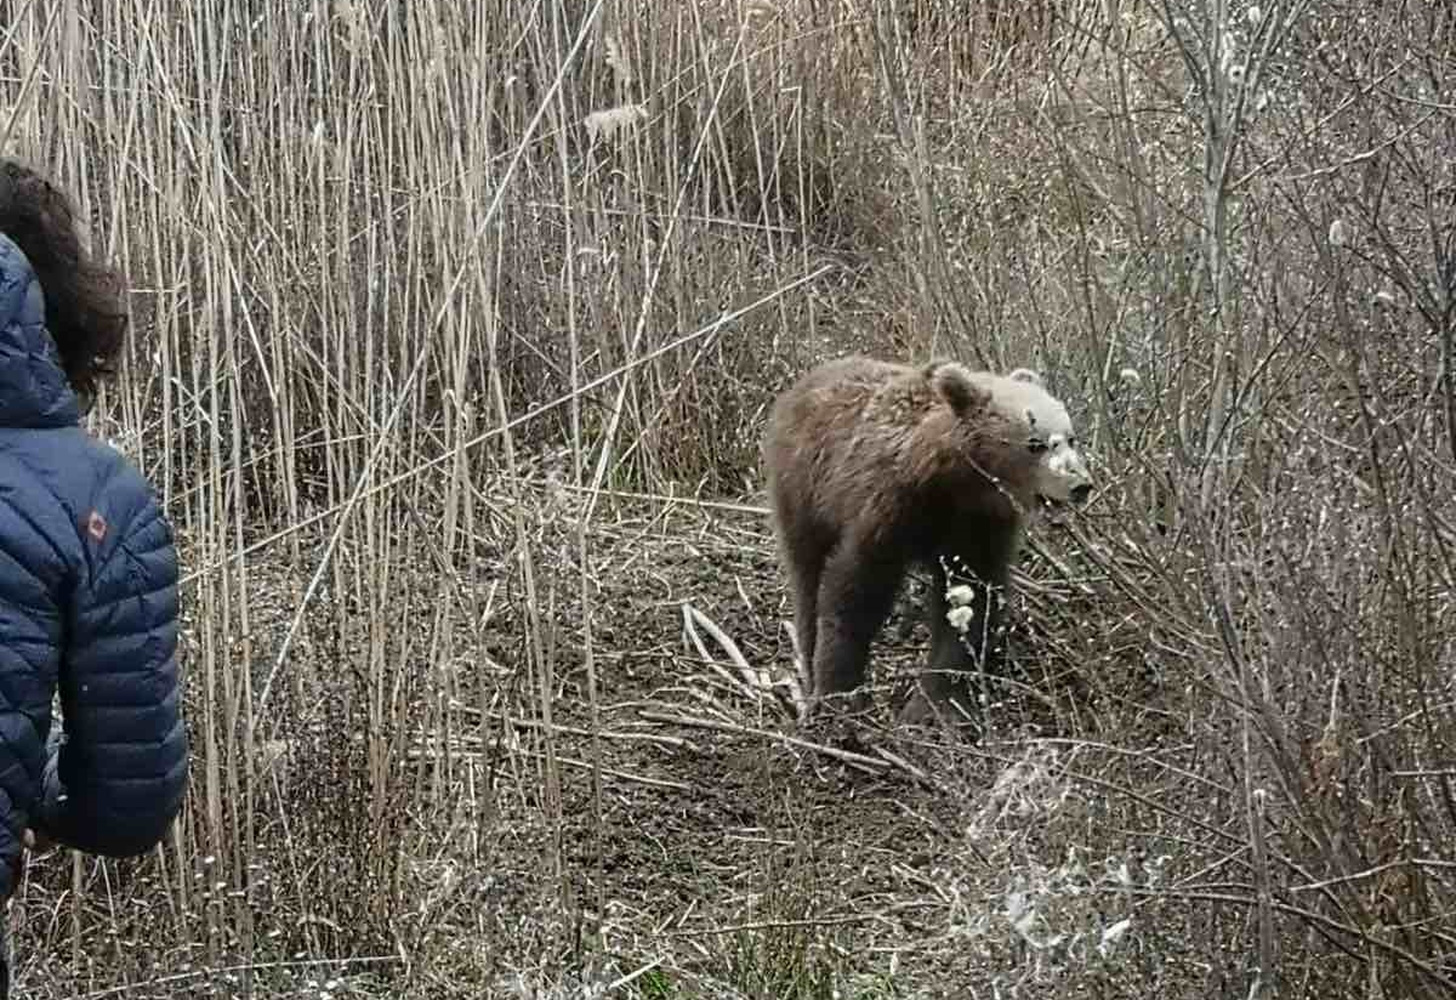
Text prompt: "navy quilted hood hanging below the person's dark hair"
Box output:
[[0, 233, 80, 428]]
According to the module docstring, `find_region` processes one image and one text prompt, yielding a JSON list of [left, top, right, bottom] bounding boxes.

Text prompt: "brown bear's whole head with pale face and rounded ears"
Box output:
[[929, 362, 1092, 504]]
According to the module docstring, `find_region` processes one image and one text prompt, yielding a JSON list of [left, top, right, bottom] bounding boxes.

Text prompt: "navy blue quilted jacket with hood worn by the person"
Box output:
[[0, 234, 188, 898]]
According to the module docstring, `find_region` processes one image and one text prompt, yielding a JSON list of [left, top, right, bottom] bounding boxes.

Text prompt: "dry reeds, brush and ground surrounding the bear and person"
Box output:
[[0, 0, 1456, 1000]]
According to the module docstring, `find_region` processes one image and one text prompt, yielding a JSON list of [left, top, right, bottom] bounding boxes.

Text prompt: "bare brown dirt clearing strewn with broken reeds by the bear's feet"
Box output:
[[436, 497, 1106, 996]]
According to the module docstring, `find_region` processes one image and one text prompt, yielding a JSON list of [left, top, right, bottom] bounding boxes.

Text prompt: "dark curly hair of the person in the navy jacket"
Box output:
[[0, 160, 130, 406]]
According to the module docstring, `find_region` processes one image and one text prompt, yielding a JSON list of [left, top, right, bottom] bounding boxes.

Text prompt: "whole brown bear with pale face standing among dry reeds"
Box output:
[[763, 357, 1092, 722]]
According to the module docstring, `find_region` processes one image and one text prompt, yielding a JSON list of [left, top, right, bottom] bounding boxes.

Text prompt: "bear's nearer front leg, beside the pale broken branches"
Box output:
[[812, 541, 904, 709]]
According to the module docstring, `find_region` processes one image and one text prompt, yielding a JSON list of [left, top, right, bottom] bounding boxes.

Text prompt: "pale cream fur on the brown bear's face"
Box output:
[[965, 368, 1092, 504]]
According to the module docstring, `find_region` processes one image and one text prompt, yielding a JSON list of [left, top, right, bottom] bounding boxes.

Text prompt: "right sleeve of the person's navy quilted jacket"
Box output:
[[35, 467, 188, 857]]
